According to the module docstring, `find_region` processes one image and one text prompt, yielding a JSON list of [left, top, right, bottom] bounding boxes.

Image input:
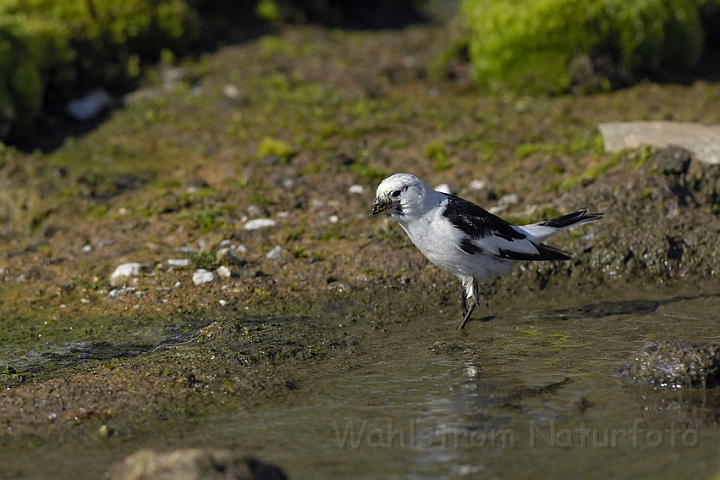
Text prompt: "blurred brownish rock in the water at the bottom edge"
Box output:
[[103, 448, 287, 480]]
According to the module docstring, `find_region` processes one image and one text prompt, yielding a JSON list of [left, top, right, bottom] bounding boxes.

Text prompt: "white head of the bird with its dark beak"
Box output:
[[372, 173, 435, 220]]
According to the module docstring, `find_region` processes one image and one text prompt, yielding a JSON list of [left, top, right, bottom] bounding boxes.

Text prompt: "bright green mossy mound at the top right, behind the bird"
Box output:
[[461, 0, 703, 93]]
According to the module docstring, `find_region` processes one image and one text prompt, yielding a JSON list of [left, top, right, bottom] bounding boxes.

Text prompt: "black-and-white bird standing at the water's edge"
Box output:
[[372, 173, 603, 330]]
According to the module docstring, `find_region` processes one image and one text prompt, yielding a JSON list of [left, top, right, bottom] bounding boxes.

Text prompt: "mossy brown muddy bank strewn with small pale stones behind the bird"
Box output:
[[0, 26, 720, 472]]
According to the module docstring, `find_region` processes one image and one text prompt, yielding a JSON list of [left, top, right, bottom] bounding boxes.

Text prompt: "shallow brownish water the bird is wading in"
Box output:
[[0, 291, 720, 479]]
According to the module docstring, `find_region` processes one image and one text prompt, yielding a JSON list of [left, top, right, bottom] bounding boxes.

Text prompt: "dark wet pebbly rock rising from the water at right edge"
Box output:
[[618, 340, 720, 388]]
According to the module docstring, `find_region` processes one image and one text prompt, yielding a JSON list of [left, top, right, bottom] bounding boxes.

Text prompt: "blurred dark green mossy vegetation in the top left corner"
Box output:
[[0, 0, 198, 140]]
